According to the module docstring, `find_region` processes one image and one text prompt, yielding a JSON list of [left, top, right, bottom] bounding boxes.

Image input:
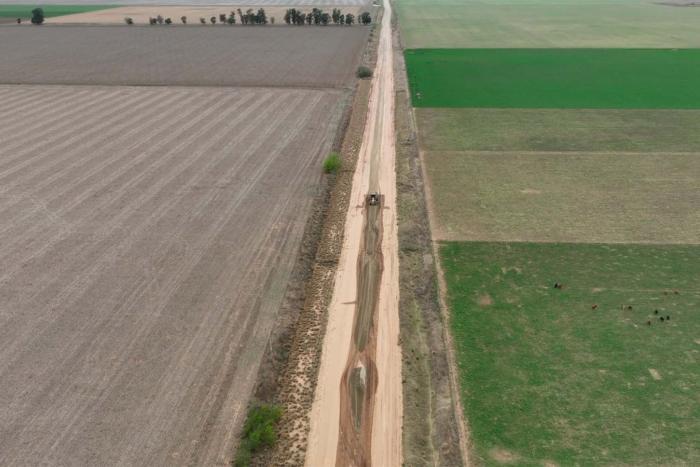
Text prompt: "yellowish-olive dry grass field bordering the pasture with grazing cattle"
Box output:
[[425, 152, 700, 243]]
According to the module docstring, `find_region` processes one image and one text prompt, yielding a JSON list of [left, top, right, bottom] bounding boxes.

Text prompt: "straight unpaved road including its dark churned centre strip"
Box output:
[[306, 2, 402, 467]]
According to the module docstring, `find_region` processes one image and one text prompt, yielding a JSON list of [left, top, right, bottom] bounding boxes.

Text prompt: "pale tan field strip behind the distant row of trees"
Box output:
[[46, 5, 369, 27]]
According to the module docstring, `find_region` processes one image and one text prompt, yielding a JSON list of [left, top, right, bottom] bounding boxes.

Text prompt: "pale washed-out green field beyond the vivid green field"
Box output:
[[396, 0, 700, 48]]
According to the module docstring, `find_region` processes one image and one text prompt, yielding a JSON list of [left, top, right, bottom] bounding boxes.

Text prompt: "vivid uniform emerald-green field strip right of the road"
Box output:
[[406, 49, 700, 109]]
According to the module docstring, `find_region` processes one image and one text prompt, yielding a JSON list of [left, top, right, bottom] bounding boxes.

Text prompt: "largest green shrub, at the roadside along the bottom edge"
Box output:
[[233, 405, 282, 467]]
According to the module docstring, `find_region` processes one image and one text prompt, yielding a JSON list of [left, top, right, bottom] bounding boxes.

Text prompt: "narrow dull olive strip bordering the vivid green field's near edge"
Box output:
[[416, 108, 700, 154]]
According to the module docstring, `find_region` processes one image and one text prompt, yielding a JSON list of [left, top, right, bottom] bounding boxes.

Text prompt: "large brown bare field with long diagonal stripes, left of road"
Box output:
[[0, 86, 345, 465]]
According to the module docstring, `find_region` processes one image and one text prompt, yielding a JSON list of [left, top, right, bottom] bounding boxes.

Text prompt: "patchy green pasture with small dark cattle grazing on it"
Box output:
[[440, 243, 700, 465]]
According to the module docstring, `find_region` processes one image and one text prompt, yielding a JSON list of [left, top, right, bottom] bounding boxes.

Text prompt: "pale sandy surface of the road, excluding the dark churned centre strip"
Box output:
[[306, 2, 402, 467]]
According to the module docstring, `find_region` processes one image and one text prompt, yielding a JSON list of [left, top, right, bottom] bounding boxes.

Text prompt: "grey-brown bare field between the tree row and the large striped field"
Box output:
[[0, 26, 369, 87]]
